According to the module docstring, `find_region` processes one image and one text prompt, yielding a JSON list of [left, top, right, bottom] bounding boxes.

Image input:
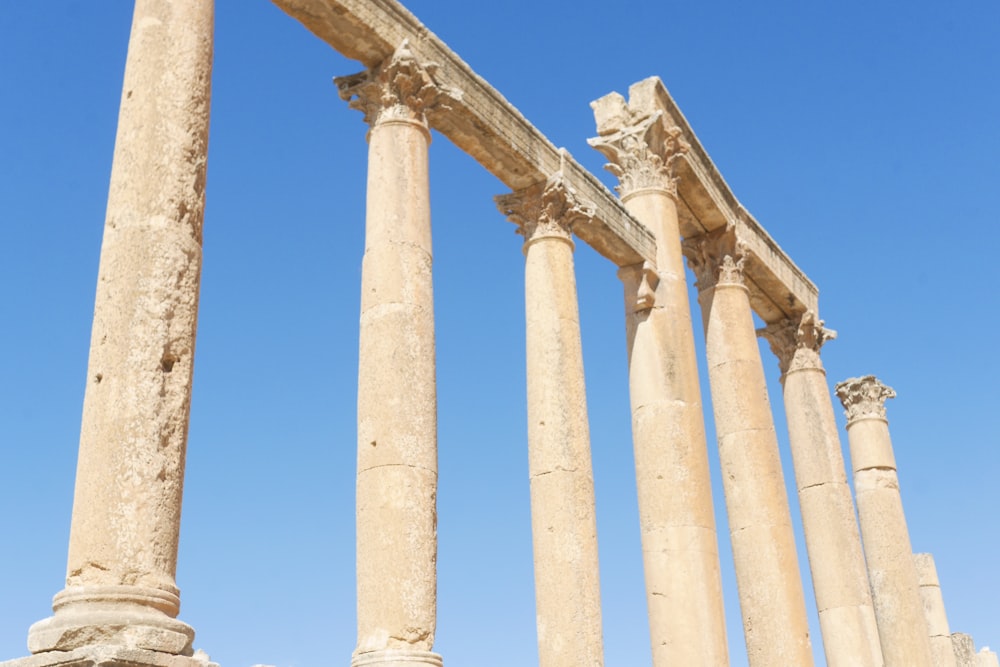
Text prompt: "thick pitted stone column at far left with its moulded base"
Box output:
[[19, 0, 213, 664]]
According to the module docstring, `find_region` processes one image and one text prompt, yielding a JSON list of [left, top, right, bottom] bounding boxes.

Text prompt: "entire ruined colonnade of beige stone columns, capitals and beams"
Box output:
[[0, 0, 997, 667]]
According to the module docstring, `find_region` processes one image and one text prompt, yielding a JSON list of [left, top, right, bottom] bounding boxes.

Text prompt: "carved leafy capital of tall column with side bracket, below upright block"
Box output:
[[587, 105, 691, 197]]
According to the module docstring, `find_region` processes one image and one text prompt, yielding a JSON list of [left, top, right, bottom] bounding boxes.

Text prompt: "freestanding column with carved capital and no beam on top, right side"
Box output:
[[836, 375, 934, 667]]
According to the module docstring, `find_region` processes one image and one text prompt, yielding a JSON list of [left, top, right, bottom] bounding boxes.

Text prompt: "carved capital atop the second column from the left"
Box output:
[[333, 40, 445, 127]]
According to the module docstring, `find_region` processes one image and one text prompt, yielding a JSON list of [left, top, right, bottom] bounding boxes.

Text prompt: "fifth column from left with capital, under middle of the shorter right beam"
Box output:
[[684, 228, 813, 667]]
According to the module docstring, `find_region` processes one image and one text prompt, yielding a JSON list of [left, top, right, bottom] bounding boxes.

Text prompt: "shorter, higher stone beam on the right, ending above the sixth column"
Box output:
[[598, 77, 819, 324]]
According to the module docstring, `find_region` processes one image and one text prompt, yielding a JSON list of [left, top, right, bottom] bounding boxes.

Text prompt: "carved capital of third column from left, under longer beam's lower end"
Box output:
[[494, 172, 594, 246]]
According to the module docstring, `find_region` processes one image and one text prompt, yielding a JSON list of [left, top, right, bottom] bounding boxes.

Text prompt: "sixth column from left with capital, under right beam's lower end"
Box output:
[[758, 311, 882, 667]]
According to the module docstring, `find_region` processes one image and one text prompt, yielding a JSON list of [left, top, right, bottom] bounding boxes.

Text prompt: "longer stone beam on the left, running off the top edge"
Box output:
[[272, 0, 656, 266]]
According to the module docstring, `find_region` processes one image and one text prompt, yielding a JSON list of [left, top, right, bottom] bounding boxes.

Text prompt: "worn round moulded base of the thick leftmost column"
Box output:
[[28, 586, 194, 664]]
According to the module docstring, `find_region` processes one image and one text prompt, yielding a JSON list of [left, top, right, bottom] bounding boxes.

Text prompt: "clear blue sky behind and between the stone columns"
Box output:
[[0, 0, 1000, 667]]
